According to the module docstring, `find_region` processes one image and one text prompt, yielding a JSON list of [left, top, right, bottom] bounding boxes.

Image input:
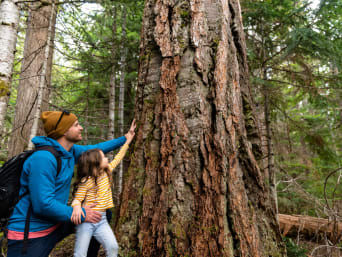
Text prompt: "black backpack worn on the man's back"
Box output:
[[0, 146, 61, 230]]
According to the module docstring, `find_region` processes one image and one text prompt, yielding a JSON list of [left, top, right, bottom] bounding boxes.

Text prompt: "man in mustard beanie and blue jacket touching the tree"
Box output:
[[7, 111, 134, 257]]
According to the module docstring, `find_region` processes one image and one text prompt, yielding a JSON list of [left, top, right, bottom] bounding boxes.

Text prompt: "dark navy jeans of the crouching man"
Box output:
[[7, 210, 112, 257]]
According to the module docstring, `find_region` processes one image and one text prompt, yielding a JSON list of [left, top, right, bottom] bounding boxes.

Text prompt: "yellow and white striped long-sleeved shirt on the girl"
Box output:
[[71, 144, 128, 211]]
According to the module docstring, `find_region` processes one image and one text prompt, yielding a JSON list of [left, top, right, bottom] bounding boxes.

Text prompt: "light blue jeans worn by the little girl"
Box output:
[[74, 212, 119, 257]]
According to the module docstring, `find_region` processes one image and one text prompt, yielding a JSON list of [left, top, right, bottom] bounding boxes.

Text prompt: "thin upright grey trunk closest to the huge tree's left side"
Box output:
[[118, 6, 127, 198]]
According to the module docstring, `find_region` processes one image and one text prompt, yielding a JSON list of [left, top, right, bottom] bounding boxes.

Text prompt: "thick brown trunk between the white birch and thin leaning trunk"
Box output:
[[9, 0, 56, 157]]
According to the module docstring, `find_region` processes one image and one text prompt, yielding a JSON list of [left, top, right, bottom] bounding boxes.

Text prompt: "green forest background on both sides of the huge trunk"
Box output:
[[0, 0, 342, 256]]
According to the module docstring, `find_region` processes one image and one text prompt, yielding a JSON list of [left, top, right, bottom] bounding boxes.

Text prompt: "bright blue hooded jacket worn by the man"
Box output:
[[8, 137, 126, 232]]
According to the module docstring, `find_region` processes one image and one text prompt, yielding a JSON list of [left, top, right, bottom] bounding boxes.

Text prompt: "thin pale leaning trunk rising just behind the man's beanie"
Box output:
[[28, 0, 56, 149]]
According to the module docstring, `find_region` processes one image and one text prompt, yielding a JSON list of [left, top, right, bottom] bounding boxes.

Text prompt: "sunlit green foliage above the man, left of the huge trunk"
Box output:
[[53, 1, 143, 143]]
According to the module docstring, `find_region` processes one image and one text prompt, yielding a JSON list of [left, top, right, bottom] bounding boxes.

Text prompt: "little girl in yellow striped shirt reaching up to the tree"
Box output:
[[71, 121, 136, 257]]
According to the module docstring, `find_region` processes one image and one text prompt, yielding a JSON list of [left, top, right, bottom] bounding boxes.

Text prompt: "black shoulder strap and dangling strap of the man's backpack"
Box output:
[[21, 145, 62, 254]]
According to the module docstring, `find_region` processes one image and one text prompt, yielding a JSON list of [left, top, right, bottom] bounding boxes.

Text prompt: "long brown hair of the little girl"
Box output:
[[72, 148, 112, 197]]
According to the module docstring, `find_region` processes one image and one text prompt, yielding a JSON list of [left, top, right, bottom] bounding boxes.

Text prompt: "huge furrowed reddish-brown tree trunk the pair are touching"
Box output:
[[116, 0, 285, 257]]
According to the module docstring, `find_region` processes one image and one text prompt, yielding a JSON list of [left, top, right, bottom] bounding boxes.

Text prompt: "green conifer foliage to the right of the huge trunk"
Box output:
[[242, 0, 342, 215]]
